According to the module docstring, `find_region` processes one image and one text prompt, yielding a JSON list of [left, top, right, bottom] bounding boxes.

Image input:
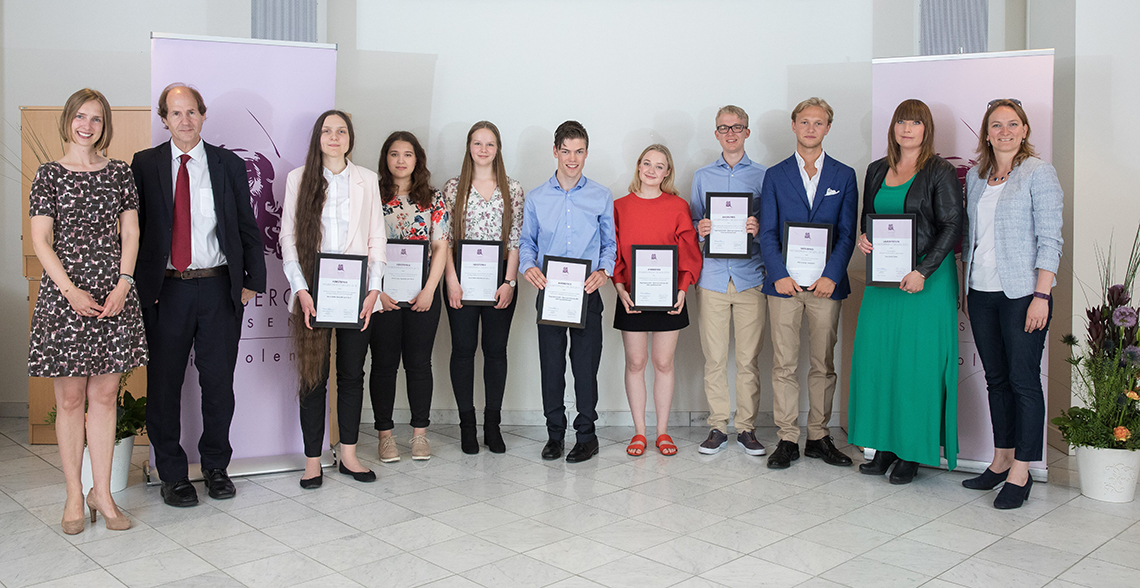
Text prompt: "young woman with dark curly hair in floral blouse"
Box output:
[[368, 131, 450, 463]]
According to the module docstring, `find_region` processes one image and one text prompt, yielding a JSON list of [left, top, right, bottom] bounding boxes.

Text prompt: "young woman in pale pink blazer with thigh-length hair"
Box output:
[[280, 111, 388, 489]]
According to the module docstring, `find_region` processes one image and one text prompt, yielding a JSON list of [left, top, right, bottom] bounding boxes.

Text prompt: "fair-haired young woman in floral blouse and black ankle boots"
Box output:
[[443, 121, 523, 454]]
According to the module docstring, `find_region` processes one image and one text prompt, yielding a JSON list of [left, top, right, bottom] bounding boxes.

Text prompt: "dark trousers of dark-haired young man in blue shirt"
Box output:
[[536, 291, 602, 443]]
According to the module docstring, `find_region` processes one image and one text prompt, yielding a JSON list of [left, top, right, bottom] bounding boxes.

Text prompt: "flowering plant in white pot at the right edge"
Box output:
[[1052, 229, 1140, 503]]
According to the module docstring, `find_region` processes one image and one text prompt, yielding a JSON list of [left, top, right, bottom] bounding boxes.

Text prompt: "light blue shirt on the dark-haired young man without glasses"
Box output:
[[519, 175, 620, 276]]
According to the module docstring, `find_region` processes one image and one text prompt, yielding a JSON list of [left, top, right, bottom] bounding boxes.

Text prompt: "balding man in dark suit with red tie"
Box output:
[[131, 84, 266, 506]]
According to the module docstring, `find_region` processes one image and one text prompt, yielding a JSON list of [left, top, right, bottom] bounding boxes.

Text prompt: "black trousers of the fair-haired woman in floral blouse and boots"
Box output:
[[447, 296, 519, 413]]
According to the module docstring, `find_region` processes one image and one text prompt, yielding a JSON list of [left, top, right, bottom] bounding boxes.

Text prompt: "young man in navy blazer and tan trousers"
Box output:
[[757, 98, 858, 468]]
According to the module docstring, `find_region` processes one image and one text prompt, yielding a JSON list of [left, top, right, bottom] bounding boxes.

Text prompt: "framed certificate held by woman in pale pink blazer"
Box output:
[[309, 253, 368, 329]]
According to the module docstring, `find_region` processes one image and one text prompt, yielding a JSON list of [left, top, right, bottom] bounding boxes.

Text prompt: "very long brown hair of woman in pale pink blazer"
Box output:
[[291, 111, 356, 391]]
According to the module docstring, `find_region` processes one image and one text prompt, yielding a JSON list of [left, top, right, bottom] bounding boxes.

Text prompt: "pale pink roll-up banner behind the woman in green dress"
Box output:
[[871, 49, 1053, 480]]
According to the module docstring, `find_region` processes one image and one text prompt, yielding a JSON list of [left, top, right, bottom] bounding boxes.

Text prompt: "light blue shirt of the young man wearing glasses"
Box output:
[[689, 149, 766, 294]]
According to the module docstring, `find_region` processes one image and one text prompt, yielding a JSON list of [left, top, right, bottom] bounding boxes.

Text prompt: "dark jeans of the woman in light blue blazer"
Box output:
[[968, 289, 1053, 462]]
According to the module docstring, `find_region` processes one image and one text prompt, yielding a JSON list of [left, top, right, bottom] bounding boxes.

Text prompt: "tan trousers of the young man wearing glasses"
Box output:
[[698, 280, 767, 433]]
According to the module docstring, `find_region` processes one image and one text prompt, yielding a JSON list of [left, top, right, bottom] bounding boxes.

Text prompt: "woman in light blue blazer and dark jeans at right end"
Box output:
[[962, 99, 1064, 508]]
